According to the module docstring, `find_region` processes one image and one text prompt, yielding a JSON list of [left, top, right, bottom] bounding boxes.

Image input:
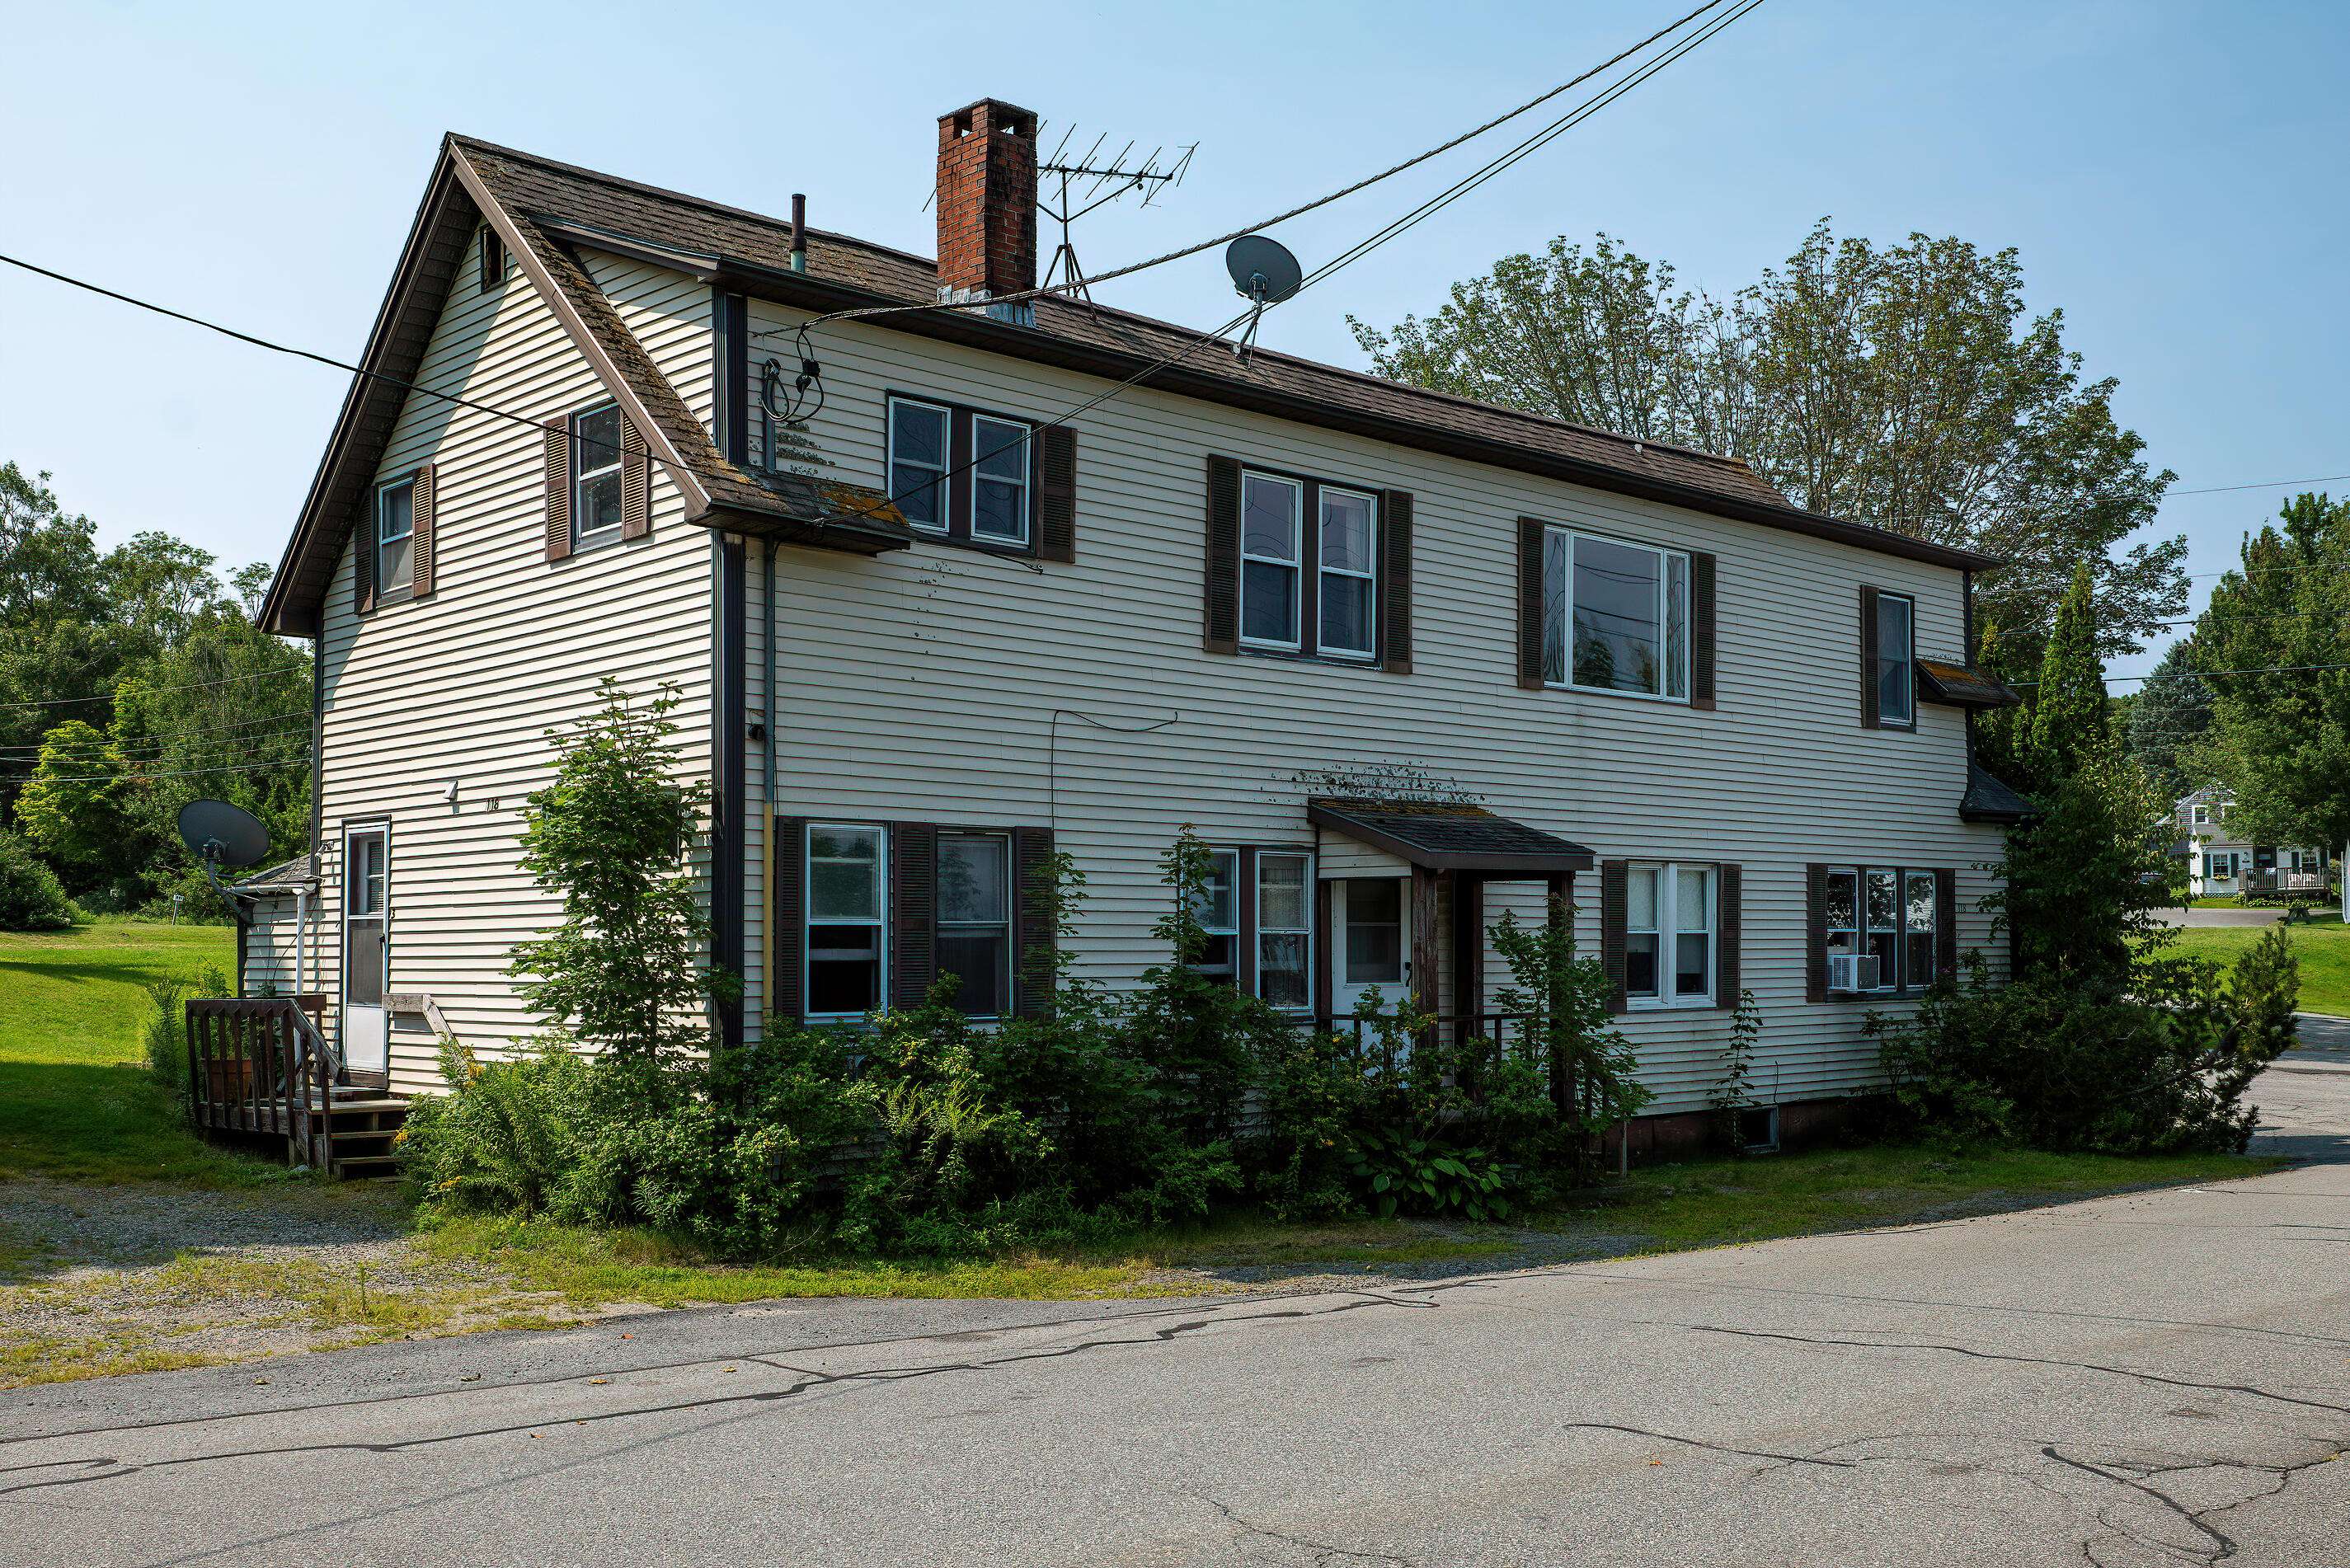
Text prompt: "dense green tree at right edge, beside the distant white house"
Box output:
[[2193, 494, 2350, 847]]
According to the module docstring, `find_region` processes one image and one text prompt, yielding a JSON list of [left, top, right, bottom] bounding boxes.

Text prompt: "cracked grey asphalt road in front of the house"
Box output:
[[0, 1049, 2350, 1568]]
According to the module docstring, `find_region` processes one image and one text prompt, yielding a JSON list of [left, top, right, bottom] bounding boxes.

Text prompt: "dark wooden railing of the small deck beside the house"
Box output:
[[188, 997, 343, 1166]]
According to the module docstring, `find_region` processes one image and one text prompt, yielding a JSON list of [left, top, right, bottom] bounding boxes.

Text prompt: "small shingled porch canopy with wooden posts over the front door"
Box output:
[[1307, 800, 1593, 1039]]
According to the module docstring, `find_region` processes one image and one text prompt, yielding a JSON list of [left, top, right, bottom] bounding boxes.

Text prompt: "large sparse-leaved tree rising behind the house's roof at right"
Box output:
[[1354, 221, 2186, 654]]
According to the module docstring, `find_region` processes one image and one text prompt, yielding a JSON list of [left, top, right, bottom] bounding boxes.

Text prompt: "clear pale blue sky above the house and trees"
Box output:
[[0, 0, 2350, 673]]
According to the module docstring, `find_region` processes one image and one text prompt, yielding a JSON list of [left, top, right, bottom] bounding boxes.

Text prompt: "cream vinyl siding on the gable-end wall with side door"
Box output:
[[320, 237, 712, 1088]]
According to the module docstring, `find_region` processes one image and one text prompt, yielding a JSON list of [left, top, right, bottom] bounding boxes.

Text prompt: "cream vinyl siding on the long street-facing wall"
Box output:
[[747, 301, 2000, 1112]]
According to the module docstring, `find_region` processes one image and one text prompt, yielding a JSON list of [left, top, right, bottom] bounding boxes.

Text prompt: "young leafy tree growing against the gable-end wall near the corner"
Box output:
[[510, 677, 709, 1065]]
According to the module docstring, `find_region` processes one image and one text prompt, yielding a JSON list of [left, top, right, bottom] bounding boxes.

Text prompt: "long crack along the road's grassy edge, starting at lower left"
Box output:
[[0, 1284, 1452, 1495]]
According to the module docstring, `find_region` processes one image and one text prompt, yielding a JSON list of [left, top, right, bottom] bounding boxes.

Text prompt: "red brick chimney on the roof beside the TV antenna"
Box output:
[[938, 99, 1036, 298]]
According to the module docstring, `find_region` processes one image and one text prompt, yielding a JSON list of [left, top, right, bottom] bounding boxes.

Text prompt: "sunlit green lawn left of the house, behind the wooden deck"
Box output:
[[0, 919, 273, 1187]]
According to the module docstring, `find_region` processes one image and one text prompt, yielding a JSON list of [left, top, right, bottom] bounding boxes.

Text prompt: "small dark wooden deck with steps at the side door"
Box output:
[[188, 997, 409, 1176]]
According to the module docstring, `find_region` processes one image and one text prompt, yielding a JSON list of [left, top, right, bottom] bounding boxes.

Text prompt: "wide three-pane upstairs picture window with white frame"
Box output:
[[1542, 529, 1690, 703]]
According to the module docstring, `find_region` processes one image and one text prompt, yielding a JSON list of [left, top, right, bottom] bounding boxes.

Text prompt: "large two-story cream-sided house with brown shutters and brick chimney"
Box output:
[[247, 101, 2028, 1138]]
